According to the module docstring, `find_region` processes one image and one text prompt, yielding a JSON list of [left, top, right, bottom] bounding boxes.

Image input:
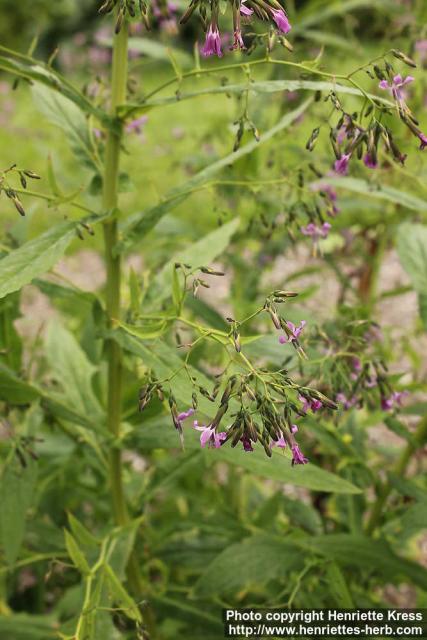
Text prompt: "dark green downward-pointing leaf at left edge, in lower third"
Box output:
[[0, 458, 37, 564]]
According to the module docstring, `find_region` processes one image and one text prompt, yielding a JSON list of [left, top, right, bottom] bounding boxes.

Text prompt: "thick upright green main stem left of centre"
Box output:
[[102, 24, 146, 595]]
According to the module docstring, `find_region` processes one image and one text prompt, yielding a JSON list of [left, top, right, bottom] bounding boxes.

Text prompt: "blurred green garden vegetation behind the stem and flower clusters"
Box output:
[[0, 0, 427, 640]]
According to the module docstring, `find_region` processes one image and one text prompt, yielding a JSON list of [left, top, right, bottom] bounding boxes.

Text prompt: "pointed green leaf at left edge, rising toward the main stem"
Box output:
[[0, 222, 76, 298]]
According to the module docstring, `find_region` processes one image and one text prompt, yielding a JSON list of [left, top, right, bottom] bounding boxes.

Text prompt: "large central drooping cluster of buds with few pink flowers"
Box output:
[[139, 290, 344, 464]]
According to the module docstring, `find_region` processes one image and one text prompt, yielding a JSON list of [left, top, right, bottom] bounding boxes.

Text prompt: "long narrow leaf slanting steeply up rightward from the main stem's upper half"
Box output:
[[115, 98, 313, 253]]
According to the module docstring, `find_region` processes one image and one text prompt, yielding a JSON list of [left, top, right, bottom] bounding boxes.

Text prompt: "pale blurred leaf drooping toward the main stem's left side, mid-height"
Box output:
[[46, 321, 104, 426]]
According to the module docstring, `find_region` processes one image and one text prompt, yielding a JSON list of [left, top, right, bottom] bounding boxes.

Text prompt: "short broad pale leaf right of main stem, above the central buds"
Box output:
[[152, 218, 239, 306]]
